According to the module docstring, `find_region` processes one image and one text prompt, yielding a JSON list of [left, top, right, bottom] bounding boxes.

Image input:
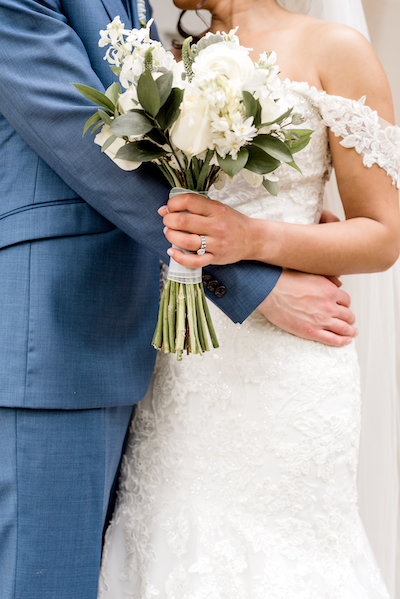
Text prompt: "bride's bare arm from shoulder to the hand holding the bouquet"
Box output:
[[165, 26, 400, 275]]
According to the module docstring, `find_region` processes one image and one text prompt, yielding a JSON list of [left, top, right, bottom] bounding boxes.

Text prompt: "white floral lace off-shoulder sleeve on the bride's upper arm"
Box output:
[[319, 94, 400, 189]]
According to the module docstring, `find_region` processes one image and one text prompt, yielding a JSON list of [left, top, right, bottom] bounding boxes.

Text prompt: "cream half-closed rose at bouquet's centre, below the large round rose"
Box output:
[[171, 86, 216, 156]]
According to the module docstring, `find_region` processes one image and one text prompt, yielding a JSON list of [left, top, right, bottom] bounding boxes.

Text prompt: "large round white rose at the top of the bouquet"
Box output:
[[193, 42, 255, 89]]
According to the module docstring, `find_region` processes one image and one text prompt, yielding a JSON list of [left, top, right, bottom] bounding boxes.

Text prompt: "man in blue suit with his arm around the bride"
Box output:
[[0, 0, 354, 599]]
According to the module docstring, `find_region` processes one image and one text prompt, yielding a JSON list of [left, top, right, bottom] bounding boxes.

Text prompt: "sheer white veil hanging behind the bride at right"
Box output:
[[278, 0, 400, 599]]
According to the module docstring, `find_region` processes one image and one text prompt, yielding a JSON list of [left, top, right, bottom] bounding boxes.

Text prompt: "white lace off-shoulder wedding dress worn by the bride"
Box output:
[[99, 80, 400, 599]]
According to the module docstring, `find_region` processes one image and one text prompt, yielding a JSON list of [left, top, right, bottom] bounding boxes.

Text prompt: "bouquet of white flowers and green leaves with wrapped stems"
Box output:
[[75, 17, 311, 360]]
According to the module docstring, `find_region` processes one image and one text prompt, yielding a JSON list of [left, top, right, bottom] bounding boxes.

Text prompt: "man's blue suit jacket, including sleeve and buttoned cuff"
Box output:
[[0, 0, 280, 409]]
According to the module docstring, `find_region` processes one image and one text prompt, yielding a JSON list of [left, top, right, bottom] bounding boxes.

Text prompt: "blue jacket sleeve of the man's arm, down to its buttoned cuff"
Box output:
[[0, 0, 281, 322]]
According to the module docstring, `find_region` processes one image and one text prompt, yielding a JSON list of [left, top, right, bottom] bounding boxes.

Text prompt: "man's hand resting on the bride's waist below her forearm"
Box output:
[[258, 270, 357, 347]]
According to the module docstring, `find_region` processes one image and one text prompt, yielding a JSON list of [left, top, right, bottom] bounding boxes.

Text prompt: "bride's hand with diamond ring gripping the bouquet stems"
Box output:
[[159, 194, 255, 268]]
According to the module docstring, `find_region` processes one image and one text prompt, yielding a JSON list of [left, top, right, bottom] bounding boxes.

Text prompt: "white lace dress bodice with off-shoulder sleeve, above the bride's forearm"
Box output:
[[210, 79, 400, 224]]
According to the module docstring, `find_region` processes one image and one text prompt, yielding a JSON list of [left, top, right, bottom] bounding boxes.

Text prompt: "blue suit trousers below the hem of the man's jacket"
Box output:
[[0, 406, 132, 599]]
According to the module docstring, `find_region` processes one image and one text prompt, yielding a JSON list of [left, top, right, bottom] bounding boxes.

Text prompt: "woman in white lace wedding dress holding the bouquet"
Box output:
[[99, 0, 400, 599]]
